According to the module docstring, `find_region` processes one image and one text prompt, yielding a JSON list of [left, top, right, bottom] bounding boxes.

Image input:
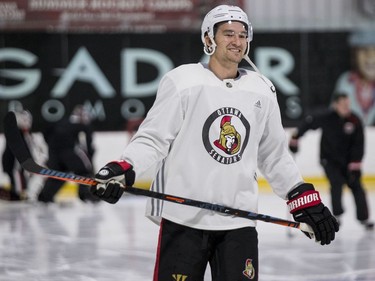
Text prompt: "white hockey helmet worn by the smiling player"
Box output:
[[201, 5, 253, 55]]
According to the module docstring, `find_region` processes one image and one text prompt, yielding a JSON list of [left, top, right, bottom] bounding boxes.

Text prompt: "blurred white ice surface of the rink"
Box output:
[[0, 185, 375, 281]]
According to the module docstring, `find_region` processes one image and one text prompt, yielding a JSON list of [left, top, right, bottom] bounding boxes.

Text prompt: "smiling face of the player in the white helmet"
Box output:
[[214, 22, 247, 64]]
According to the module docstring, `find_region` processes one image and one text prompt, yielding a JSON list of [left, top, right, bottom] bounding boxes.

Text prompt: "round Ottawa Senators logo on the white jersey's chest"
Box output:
[[202, 107, 250, 165]]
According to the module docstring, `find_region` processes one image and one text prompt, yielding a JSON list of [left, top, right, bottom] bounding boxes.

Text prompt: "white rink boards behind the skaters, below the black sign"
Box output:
[[0, 128, 375, 185]]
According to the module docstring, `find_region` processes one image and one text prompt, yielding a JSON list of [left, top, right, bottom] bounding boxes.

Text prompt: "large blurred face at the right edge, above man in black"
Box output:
[[356, 47, 375, 82]]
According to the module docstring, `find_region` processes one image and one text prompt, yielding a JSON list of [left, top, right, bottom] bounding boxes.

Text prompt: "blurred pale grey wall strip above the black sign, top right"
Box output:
[[244, 0, 375, 30]]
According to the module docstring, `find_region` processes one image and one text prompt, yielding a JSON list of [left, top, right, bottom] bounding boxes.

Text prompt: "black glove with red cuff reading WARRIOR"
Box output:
[[287, 183, 339, 245]]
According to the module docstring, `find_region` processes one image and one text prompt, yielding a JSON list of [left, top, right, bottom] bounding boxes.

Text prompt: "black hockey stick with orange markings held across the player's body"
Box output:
[[4, 111, 314, 233]]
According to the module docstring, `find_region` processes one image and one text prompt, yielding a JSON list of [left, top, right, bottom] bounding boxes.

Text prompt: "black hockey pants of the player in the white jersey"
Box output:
[[153, 219, 258, 281]]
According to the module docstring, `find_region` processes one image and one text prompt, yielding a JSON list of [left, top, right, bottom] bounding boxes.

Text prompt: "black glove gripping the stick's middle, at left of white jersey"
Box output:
[[90, 160, 135, 204]]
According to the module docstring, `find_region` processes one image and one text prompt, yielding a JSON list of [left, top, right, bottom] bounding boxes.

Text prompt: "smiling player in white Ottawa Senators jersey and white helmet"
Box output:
[[91, 5, 338, 281]]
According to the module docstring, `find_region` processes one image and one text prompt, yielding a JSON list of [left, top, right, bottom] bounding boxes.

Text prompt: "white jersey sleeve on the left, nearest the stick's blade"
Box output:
[[121, 76, 183, 176]]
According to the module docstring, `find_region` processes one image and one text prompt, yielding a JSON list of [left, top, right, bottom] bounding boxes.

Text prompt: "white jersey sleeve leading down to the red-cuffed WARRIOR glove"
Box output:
[[258, 95, 303, 199]]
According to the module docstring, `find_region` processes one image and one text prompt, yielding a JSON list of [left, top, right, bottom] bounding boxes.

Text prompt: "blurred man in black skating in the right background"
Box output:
[[289, 93, 374, 229]]
